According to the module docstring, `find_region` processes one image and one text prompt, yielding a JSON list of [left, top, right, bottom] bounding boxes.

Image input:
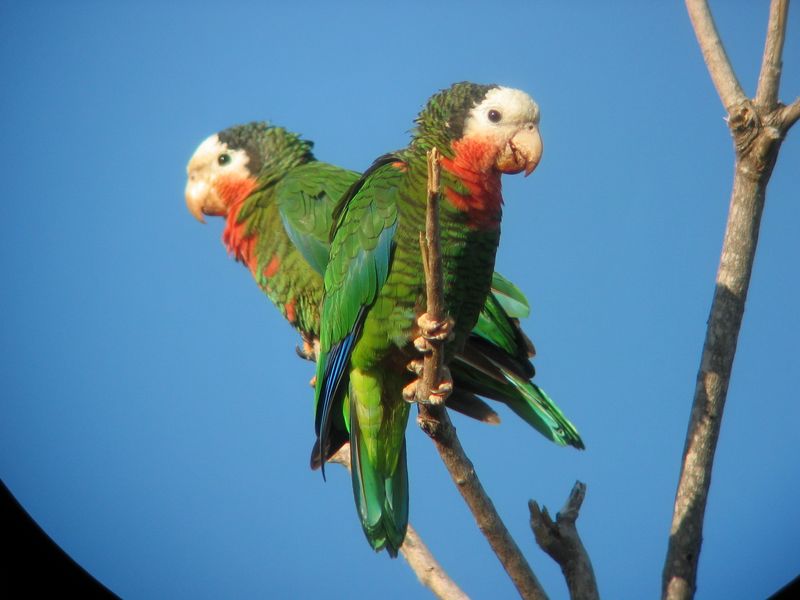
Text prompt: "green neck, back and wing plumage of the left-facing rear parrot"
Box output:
[[219, 123, 359, 341]]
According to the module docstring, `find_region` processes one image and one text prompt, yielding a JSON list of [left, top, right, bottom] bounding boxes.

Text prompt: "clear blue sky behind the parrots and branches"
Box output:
[[0, 0, 800, 599]]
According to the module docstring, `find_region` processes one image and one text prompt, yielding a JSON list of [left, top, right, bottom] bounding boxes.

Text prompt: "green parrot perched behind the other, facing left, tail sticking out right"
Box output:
[[186, 122, 583, 458]]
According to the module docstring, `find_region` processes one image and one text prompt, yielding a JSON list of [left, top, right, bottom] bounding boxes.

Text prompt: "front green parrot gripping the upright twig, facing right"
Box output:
[[315, 82, 564, 556]]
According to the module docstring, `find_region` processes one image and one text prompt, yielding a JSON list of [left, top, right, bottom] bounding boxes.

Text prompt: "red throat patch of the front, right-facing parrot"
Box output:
[[441, 137, 503, 229]]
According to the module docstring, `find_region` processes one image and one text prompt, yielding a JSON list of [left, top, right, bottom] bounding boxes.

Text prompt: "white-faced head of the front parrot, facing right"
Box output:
[[412, 82, 542, 175]]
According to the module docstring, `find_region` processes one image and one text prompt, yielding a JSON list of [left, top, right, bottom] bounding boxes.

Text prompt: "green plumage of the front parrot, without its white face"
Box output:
[[316, 84, 564, 555]]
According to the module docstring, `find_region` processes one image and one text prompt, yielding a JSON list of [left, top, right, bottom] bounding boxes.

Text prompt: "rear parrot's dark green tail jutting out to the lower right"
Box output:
[[450, 355, 584, 450]]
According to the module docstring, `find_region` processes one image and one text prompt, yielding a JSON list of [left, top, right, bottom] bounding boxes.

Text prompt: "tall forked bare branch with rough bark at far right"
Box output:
[[662, 0, 800, 600]]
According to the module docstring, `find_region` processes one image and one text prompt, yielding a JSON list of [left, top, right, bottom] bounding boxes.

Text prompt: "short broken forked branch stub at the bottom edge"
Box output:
[[528, 481, 600, 600]]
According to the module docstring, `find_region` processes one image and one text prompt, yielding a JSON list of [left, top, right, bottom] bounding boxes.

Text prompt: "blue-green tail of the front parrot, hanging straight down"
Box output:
[[350, 396, 408, 558]]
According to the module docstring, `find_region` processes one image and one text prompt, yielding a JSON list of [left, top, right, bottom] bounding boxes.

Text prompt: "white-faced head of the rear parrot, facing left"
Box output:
[[185, 122, 313, 222]]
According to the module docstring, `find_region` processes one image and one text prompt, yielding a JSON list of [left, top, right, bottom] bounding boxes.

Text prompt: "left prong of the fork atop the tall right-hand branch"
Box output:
[[686, 0, 747, 112]]
